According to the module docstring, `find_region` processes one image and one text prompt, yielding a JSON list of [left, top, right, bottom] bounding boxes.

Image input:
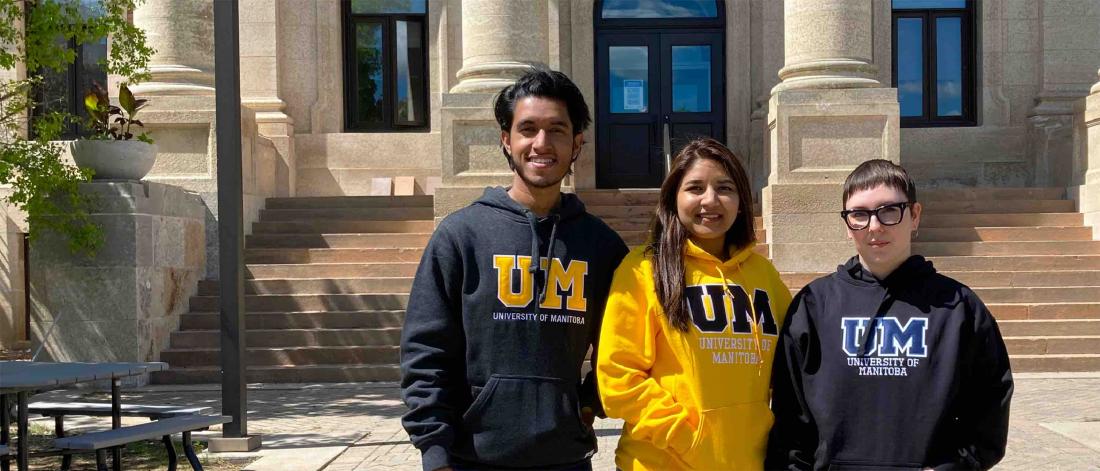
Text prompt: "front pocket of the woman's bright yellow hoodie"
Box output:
[[680, 403, 774, 470]]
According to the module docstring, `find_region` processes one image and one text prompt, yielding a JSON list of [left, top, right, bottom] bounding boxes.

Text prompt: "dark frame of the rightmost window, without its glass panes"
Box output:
[[890, 0, 978, 128]]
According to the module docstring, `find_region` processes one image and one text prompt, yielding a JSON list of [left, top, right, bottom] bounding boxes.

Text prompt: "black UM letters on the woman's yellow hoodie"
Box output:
[[684, 285, 779, 336]]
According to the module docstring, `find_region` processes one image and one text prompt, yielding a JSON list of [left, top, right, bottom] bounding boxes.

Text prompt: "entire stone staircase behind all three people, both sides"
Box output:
[[154, 184, 1100, 383]]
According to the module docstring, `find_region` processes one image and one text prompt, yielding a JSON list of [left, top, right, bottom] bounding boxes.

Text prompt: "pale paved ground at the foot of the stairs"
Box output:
[[25, 373, 1100, 471]]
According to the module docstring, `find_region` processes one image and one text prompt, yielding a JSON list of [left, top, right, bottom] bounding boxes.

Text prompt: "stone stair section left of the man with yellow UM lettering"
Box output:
[[153, 196, 426, 383]]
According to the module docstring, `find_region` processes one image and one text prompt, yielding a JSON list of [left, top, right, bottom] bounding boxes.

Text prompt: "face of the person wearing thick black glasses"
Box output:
[[844, 185, 921, 280]]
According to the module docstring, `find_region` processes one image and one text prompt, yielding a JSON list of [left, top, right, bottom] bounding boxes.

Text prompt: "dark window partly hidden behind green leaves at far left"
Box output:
[[33, 0, 107, 140]]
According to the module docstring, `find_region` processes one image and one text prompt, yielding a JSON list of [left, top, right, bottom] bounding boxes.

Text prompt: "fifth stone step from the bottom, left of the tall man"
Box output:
[[190, 293, 409, 313]]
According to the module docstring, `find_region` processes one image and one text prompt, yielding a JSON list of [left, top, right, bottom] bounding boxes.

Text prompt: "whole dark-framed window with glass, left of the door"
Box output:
[[343, 0, 428, 132]]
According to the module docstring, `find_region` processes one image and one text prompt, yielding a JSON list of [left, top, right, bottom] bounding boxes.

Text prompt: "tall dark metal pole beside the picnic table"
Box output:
[[213, 0, 249, 438]]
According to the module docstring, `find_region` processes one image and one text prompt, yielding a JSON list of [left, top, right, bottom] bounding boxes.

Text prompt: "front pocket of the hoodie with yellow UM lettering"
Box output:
[[462, 374, 595, 467]]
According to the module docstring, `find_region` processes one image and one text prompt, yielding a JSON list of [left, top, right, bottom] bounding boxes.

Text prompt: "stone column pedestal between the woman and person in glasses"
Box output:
[[762, 88, 899, 272]]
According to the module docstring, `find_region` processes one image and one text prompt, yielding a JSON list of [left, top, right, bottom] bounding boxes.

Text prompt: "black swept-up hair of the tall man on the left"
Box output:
[[493, 68, 592, 169]]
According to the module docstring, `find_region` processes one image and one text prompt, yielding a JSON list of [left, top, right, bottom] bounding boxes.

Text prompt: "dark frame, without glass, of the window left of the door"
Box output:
[[340, 0, 431, 132]]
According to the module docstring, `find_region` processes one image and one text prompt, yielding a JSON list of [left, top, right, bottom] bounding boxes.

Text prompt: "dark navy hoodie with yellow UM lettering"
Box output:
[[402, 187, 627, 470]]
